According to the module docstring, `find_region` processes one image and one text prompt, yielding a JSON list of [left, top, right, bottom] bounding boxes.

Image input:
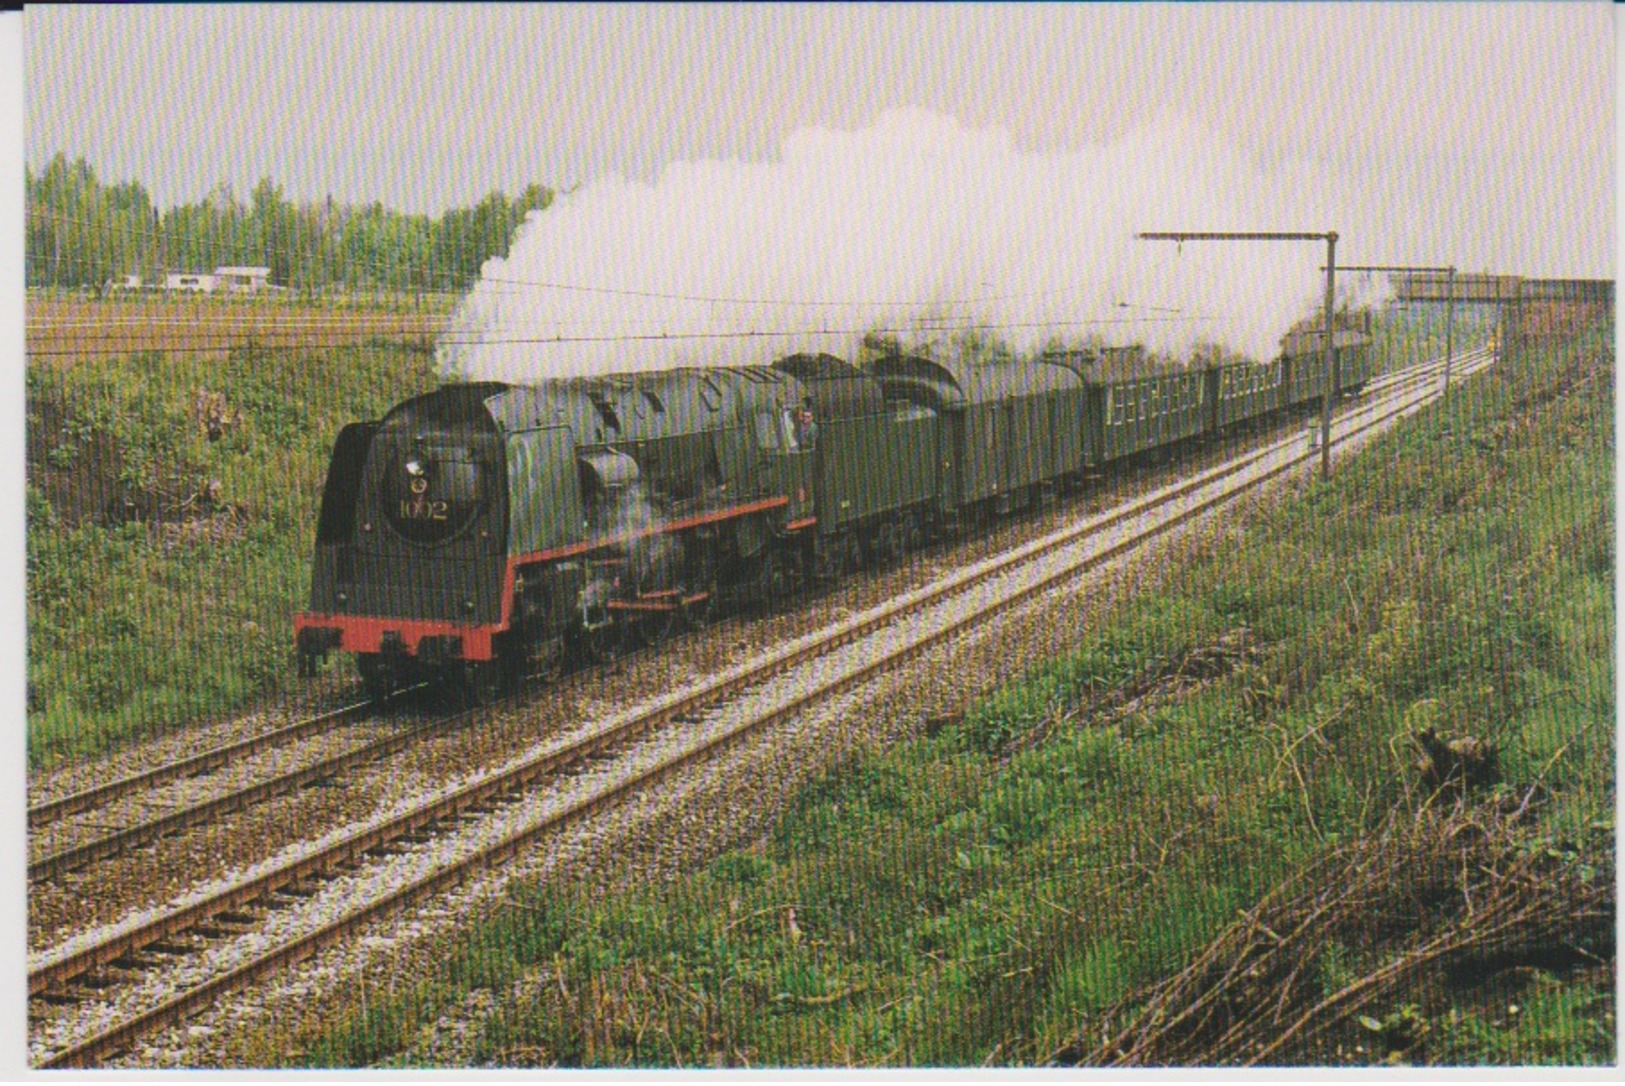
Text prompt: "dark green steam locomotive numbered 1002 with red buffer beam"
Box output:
[[294, 367, 814, 697]]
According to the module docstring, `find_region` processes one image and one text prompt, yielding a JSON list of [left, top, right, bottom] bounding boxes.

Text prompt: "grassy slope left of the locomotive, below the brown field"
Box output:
[[28, 343, 436, 769]]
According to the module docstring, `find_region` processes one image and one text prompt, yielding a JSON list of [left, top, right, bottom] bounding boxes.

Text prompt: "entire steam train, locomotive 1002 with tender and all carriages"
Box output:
[[294, 328, 1370, 701]]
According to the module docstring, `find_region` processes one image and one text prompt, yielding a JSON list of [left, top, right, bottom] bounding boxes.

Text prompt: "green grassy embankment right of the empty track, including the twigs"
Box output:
[[297, 325, 1615, 1066]]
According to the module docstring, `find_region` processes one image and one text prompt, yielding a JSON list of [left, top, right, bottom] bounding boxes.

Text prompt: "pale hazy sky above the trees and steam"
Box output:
[[23, 2, 1614, 276]]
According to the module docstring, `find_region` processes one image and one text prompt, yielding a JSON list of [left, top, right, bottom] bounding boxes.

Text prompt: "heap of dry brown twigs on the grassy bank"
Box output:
[[1055, 806, 1614, 1066]]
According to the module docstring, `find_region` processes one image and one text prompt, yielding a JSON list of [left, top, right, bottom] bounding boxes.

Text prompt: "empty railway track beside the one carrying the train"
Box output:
[[29, 356, 1485, 1066]]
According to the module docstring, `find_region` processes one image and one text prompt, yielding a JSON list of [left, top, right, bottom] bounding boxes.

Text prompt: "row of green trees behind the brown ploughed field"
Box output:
[[24, 153, 554, 294]]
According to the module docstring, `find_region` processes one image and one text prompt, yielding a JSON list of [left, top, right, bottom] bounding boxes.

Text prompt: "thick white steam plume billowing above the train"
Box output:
[[439, 111, 1324, 382]]
